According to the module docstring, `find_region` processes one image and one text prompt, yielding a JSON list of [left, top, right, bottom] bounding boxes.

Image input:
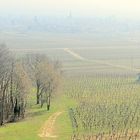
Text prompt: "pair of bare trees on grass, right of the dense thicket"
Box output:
[[23, 54, 61, 110]]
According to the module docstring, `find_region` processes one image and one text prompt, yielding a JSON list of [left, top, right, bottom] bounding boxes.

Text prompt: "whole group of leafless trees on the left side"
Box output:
[[0, 45, 61, 125]]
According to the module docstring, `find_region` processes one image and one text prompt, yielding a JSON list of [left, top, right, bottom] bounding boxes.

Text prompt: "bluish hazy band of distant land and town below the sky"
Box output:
[[0, 16, 140, 35]]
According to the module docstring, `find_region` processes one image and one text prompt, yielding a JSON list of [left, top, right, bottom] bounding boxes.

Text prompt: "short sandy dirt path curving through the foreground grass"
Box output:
[[38, 112, 62, 138]]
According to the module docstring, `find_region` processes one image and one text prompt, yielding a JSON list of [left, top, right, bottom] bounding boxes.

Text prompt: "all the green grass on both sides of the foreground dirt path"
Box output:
[[0, 91, 75, 140]]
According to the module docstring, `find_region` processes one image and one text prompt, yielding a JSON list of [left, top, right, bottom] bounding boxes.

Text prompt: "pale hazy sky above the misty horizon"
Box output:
[[0, 0, 140, 17]]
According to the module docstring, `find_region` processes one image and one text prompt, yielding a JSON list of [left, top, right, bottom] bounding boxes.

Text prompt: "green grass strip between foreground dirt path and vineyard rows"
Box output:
[[47, 96, 76, 140]]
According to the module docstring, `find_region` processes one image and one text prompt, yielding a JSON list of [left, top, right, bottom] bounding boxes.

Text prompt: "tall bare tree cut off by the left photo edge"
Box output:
[[0, 44, 11, 125]]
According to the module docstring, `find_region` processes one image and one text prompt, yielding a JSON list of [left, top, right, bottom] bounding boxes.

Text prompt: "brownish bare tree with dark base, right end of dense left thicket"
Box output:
[[13, 62, 30, 119]]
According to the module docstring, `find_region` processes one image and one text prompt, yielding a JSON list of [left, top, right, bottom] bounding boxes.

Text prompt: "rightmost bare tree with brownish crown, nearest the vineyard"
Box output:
[[38, 62, 60, 110]]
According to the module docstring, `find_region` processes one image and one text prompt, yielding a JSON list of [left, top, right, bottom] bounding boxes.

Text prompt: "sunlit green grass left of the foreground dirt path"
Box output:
[[0, 110, 51, 140]]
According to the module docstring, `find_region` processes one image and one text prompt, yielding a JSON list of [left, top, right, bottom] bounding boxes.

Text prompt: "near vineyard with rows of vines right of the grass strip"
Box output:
[[65, 74, 140, 140]]
